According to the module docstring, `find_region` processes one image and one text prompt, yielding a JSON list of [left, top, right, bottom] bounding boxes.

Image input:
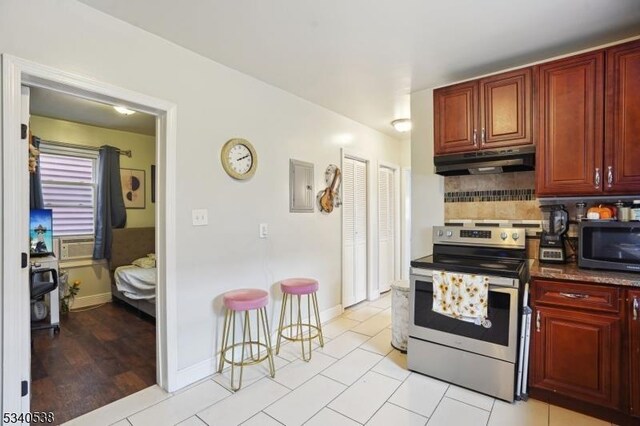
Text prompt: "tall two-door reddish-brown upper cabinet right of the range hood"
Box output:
[[536, 41, 640, 197]]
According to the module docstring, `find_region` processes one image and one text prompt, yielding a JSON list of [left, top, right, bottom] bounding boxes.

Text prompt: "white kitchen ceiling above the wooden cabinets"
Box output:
[[80, 0, 640, 136]]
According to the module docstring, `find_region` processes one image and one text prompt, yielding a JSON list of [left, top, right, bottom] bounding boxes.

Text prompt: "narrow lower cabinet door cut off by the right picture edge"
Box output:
[[626, 290, 640, 416]]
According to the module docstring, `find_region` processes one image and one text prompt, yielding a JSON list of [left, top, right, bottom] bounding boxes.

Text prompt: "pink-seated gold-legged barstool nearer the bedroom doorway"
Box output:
[[218, 289, 276, 391]]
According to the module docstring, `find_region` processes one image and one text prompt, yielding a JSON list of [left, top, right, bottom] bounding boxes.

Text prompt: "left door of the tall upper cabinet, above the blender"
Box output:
[[536, 51, 604, 196]]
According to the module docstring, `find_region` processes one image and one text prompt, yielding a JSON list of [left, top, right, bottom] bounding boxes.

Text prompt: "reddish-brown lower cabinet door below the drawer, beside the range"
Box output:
[[530, 306, 622, 408]]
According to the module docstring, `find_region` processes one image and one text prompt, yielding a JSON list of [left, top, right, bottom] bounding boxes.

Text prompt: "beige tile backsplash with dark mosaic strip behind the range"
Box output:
[[444, 172, 542, 221]]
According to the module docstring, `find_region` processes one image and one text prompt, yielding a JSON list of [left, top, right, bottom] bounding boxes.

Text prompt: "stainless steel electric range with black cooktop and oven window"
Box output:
[[407, 224, 530, 401]]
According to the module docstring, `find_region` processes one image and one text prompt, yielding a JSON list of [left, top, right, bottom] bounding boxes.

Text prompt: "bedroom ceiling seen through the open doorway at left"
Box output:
[[29, 87, 156, 136]]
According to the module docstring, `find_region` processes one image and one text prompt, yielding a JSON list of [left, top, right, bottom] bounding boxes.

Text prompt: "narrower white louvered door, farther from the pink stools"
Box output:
[[378, 166, 398, 293]]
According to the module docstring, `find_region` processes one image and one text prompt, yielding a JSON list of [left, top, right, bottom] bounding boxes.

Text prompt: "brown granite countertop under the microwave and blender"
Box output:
[[529, 260, 640, 287]]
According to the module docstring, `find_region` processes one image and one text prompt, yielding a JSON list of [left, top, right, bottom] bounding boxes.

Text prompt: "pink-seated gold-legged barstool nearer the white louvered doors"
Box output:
[[276, 278, 324, 361]]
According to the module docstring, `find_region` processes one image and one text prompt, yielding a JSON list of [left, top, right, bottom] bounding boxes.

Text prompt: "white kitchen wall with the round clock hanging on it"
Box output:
[[0, 0, 402, 369]]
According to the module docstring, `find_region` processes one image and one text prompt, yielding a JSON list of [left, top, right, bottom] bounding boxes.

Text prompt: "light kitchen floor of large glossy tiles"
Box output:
[[67, 294, 609, 426]]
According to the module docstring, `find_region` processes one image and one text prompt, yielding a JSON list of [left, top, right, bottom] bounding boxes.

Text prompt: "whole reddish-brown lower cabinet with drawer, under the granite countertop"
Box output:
[[529, 278, 640, 425]]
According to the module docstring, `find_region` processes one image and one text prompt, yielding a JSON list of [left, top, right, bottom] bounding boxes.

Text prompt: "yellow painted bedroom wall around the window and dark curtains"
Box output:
[[30, 115, 155, 308]]
